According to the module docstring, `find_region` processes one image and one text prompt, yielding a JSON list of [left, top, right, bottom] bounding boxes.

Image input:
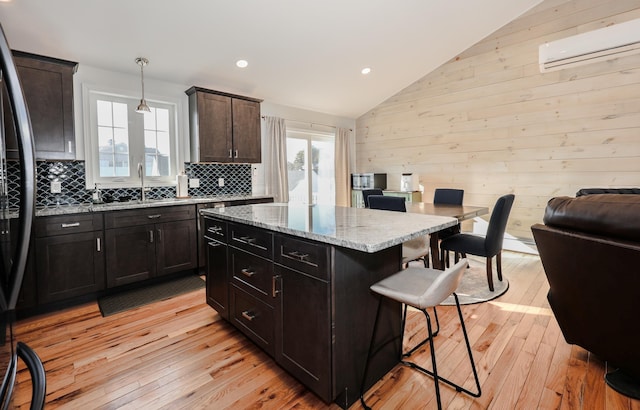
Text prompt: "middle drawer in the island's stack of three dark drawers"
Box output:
[[229, 248, 275, 305]]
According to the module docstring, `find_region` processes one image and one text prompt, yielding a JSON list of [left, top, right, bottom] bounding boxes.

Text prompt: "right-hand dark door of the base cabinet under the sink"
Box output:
[[155, 219, 198, 275]]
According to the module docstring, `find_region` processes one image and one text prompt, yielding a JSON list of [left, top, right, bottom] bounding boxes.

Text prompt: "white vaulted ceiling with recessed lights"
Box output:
[[0, 0, 541, 118]]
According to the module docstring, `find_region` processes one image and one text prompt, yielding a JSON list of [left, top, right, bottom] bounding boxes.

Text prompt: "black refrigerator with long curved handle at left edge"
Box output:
[[0, 26, 46, 409]]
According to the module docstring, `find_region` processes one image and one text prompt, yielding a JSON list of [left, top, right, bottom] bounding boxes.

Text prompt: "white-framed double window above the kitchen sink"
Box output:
[[87, 90, 177, 188]]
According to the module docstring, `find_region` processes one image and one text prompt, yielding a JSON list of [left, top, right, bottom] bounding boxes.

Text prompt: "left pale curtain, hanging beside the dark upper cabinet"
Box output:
[[265, 117, 289, 202]]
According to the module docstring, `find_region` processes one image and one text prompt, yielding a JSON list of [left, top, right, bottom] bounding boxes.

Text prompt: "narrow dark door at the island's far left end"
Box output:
[[206, 240, 229, 319]]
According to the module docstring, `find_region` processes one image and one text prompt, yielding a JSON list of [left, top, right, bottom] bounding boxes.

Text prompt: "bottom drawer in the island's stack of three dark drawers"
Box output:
[[231, 285, 275, 356]]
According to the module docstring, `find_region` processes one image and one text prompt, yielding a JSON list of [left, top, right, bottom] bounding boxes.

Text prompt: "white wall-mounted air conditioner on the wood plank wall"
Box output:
[[538, 19, 640, 72]]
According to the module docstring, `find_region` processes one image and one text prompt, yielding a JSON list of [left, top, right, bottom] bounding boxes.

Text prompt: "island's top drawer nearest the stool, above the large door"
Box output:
[[274, 235, 330, 280]]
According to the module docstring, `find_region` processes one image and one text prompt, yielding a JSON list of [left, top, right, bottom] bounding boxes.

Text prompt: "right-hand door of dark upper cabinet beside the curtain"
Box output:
[[232, 98, 262, 163]]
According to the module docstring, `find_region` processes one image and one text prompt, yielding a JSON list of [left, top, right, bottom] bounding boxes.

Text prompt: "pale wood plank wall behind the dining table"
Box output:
[[356, 0, 640, 240]]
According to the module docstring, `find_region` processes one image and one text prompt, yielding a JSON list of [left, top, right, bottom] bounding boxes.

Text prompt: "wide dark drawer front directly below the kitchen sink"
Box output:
[[104, 205, 196, 229]]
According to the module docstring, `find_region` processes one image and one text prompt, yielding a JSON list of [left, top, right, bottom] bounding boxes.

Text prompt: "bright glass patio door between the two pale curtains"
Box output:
[[287, 130, 336, 205]]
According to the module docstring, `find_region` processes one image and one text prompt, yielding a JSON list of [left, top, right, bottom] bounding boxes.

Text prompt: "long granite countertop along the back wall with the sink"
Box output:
[[36, 195, 271, 216]]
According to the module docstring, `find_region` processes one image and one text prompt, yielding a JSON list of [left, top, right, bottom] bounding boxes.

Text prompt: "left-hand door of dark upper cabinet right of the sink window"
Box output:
[[199, 92, 233, 162]]
